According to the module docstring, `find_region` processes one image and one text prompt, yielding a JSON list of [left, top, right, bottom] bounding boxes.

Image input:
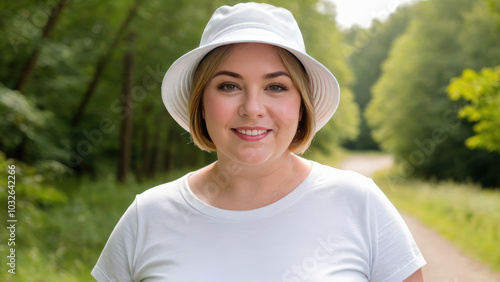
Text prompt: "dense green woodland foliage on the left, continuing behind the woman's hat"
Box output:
[[0, 0, 359, 179]]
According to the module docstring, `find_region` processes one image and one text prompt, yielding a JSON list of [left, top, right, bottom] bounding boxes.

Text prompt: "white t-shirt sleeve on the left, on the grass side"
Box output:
[[91, 199, 138, 282]]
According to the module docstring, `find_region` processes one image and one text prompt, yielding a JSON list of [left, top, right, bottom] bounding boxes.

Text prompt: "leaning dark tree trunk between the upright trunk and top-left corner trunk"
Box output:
[[71, 0, 142, 127]]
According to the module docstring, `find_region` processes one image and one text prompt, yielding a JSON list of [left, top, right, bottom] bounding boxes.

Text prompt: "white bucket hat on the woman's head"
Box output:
[[161, 3, 340, 131]]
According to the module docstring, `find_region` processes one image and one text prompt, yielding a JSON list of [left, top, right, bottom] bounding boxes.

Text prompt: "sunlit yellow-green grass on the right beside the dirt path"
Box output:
[[374, 172, 500, 271]]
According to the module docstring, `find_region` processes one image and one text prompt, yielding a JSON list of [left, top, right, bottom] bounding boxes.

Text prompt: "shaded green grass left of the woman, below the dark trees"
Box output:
[[0, 171, 192, 282]]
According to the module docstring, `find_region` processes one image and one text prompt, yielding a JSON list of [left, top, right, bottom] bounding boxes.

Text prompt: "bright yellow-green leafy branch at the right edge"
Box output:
[[447, 67, 500, 153]]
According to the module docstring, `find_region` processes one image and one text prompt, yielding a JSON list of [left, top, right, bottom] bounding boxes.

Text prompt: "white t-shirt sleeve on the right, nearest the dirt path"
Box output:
[[367, 181, 426, 282]]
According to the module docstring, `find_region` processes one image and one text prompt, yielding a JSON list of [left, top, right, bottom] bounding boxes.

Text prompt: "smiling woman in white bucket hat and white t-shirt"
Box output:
[[92, 3, 425, 281]]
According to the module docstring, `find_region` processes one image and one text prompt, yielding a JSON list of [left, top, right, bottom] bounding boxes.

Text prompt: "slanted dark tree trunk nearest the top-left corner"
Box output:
[[14, 0, 68, 92]]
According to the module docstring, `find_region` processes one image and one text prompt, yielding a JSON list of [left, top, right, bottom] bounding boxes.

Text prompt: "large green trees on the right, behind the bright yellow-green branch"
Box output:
[[366, 0, 500, 187]]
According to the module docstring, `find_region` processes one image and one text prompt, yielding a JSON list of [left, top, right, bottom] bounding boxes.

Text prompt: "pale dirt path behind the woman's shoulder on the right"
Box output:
[[341, 156, 500, 282]]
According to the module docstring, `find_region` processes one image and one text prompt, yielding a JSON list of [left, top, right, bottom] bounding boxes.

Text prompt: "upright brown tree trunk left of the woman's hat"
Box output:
[[117, 33, 134, 183]]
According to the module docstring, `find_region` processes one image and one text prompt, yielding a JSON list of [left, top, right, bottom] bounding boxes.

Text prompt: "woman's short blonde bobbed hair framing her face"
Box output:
[[189, 44, 316, 155]]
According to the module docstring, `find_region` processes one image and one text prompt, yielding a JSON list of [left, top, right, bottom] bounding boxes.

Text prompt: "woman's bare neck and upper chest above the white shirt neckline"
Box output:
[[190, 153, 310, 210]]
